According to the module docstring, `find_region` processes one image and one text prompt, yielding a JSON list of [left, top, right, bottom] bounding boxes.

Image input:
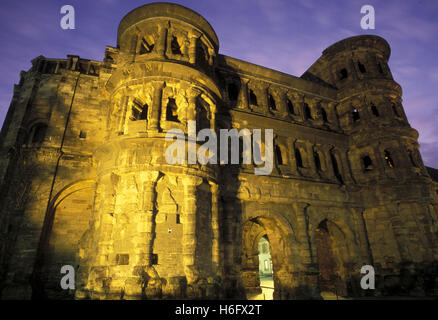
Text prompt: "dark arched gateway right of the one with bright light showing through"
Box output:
[[315, 219, 348, 299]]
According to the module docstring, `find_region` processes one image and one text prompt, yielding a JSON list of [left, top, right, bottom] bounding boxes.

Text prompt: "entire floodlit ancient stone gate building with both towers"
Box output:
[[0, 3, 438, 299]]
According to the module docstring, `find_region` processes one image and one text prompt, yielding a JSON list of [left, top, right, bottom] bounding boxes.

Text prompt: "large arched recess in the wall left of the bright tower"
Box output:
[[32, 180, 95, 299]]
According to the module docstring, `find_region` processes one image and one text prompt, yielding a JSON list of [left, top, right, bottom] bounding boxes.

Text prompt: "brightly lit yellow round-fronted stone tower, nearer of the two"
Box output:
[[76, 3, 221, 299]]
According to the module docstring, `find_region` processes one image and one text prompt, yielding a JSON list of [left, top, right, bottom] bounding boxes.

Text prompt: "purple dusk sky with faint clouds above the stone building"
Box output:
[[0, 0, 438, 168]]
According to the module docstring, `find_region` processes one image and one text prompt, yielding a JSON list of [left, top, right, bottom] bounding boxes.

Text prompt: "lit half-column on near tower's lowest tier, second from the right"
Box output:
[[182, 176, 202, 285]]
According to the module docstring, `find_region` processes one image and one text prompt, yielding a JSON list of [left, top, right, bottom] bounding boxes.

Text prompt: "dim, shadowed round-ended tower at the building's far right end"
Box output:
[[304, 35, 438, 292]]
